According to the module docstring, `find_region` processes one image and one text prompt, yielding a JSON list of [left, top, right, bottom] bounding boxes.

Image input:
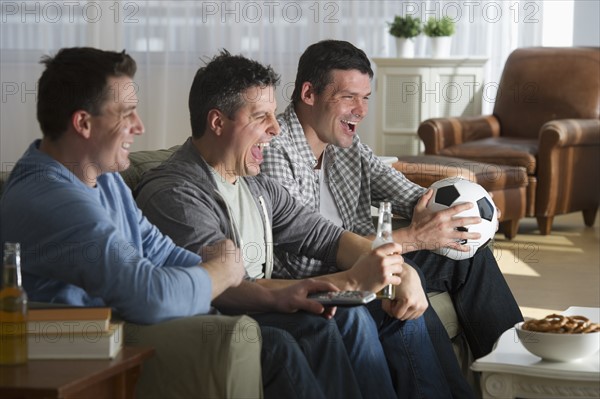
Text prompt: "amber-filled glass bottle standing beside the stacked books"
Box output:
[[0, 242, 27, 365]]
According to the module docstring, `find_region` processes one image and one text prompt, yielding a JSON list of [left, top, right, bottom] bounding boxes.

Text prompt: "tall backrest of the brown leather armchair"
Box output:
[[494, 47, 600, 139]]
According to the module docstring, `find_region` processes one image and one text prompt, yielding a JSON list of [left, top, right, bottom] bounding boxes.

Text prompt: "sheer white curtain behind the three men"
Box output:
[[0, 0, 543, 166]]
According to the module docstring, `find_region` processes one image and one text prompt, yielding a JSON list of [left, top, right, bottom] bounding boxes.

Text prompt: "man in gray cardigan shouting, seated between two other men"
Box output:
[[135, 51, 460, 397]]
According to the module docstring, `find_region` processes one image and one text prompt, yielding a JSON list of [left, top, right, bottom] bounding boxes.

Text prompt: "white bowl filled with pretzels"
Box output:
[[515, 314, 600, 362]]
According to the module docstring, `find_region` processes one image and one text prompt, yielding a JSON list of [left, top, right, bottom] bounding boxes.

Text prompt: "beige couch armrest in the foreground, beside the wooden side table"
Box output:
[[125, 315, 263, 399]]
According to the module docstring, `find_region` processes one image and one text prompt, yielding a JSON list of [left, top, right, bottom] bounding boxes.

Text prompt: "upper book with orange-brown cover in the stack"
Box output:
[[27, 306, 112, 334]]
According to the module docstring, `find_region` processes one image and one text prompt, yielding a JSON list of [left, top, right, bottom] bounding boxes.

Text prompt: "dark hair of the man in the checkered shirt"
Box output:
[[292, 40, 373, 104]]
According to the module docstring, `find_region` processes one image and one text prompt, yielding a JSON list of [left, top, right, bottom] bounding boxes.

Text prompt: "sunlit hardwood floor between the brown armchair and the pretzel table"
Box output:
[[494, 212, 600, 322]]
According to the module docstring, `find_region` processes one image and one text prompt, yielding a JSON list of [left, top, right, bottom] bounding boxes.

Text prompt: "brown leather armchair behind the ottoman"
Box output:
[[418, 47, 600, 235]]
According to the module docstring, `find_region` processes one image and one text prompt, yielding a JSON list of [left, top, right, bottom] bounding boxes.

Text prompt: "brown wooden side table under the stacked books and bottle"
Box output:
[[0, 347, 154, 399]]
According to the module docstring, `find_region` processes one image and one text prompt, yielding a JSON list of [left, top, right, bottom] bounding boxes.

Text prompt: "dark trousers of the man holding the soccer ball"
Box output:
[[404, 248, 523, 359]]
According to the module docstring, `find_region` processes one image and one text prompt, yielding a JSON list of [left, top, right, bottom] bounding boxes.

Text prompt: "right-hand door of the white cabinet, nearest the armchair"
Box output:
[[423, 67, 483, 119]]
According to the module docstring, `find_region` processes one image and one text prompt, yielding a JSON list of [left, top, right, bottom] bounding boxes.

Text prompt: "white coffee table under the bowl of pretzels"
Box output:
[[471, 307, 600, 398]]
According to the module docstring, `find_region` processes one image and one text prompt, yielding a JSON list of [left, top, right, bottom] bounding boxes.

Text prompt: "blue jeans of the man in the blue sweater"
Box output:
[[252, 312, 361, 399]]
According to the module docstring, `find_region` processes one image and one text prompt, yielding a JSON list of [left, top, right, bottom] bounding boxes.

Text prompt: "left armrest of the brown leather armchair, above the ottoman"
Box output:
[[418, 115, 500, 155]]
